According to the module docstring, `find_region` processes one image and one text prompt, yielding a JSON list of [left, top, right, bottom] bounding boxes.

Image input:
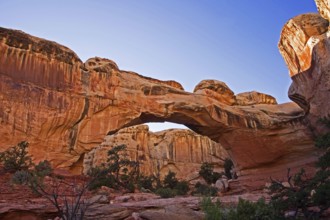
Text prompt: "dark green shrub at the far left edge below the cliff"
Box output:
[[0, 141, 32, 173]]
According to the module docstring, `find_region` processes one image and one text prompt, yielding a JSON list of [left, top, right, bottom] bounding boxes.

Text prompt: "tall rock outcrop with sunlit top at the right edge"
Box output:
[[279, 3, 330, 134]]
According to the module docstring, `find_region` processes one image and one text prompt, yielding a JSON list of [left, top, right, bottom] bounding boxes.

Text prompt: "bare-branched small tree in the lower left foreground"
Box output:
[[12, 160, 92, 220]]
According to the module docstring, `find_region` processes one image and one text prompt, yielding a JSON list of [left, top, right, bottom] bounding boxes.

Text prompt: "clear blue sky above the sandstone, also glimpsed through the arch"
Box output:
[[0, 0, 317, 130]]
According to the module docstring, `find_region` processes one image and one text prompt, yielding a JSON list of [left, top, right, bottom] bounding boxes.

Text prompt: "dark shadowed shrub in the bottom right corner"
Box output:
[[270, 117, 330, 219]]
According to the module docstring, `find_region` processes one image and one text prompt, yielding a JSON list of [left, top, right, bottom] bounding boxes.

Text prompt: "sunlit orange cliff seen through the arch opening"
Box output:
[[84, 125, 229, 180]]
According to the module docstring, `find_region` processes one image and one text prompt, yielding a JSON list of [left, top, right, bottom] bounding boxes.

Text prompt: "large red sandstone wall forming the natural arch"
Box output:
[[0, 26, 320, 190]]
